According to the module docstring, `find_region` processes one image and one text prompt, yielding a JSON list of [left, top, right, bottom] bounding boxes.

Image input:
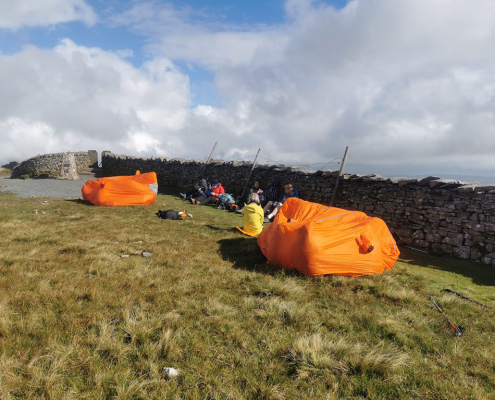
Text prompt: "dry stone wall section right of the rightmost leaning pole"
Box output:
[[337, 176, 495, 266]]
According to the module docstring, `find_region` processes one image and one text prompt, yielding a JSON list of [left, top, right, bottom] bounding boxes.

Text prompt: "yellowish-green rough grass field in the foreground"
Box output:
[[0, 190, 495, 400]]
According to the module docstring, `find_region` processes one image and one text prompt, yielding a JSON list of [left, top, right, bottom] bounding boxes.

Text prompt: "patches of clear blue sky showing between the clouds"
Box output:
[[0, 0, 347, 106]]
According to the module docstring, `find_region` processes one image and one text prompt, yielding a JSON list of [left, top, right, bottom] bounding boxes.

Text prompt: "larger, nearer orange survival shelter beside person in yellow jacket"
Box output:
[[258, 198, 400, 276]]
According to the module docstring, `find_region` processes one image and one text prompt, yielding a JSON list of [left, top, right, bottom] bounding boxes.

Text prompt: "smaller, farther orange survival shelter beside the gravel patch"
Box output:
[[81, 171, 158, 207]]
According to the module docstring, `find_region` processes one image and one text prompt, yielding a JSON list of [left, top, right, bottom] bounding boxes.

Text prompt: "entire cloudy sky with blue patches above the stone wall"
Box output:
[[0, 0, 495, 181]]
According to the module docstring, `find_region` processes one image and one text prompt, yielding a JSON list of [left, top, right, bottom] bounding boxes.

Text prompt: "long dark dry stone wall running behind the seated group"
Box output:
[[102, 152, 495, 266]]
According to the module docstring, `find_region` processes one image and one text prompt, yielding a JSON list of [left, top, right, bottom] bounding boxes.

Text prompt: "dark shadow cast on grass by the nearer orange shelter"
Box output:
[[218, 233, 300, 276]]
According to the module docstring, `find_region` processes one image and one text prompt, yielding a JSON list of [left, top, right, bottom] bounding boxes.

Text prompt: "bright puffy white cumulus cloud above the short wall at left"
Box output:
[[0, 39, 189, 161]]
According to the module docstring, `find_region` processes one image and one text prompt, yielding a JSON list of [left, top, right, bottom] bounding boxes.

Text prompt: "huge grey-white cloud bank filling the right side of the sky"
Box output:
[[121, 0, 495, 173]]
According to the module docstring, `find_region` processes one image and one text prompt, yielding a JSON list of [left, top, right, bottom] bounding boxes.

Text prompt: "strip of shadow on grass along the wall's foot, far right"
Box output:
[[399, 246, 495, 286]]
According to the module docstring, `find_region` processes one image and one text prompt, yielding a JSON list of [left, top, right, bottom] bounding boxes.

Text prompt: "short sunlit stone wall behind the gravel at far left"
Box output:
[[11, 150, 98, 178]]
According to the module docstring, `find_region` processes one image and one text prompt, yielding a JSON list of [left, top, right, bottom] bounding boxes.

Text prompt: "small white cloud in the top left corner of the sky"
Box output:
[[0, 0, 97, 30]]
